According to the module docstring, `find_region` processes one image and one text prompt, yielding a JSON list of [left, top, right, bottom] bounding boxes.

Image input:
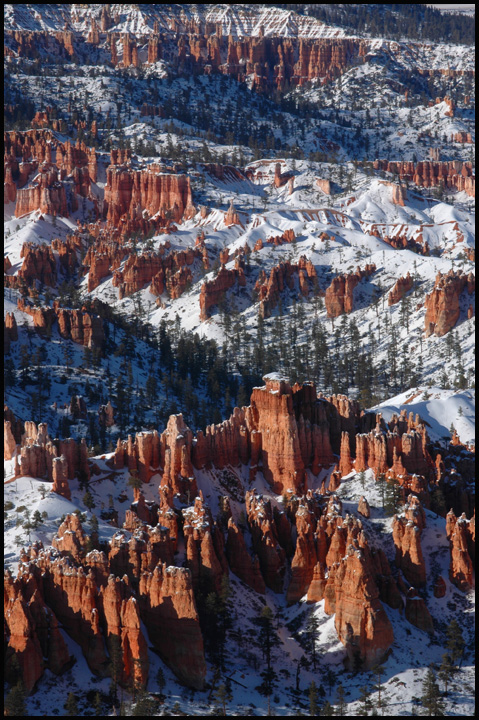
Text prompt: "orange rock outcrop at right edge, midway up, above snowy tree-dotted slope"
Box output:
[[424, 270, 475, 337]]
